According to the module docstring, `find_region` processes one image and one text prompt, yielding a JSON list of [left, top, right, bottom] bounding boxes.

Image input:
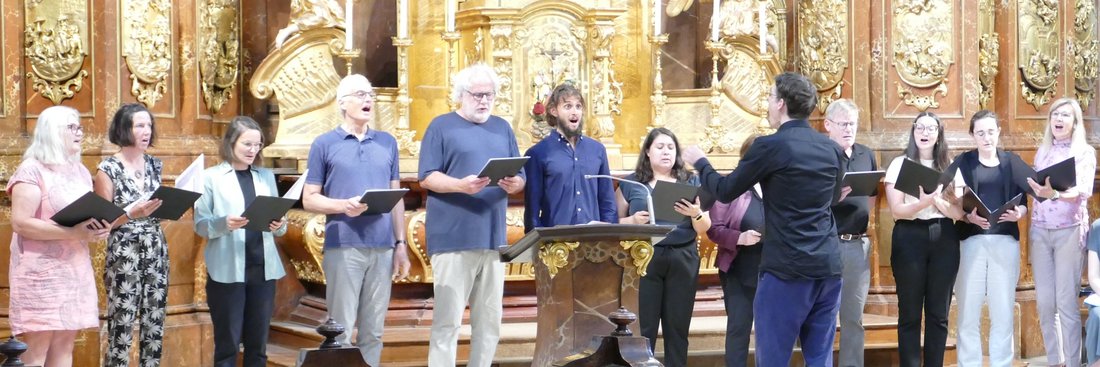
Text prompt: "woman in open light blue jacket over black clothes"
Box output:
[[195, 116, 286, 367]]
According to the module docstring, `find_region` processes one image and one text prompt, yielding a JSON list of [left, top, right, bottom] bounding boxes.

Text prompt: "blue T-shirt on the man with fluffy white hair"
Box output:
[[419, 112, 526, 255]]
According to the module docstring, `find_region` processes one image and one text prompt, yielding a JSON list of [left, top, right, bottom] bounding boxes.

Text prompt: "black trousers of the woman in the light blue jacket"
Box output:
[[207, 264, 275, 367]]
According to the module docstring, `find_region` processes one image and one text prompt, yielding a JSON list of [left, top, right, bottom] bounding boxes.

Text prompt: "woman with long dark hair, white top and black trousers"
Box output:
[[883, 112, 963, 367]]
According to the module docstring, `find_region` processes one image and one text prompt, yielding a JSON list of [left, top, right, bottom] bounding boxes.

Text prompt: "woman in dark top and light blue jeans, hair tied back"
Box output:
[[948, 110, 1027, 366]]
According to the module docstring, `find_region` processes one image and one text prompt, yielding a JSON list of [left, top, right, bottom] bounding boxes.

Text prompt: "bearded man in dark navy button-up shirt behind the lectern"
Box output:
[[524, 84, 618, 232]]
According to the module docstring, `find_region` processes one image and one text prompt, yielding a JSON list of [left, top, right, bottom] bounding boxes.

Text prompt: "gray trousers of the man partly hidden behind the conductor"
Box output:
[[837, 236, 871, 367]]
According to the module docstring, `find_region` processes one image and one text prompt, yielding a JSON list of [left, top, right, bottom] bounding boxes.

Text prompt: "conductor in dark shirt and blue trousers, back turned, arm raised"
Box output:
[[683, 73, 845, 366]]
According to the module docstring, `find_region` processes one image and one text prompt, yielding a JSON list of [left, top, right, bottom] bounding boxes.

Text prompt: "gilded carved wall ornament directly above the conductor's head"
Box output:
[[799, 0, 848, 112]]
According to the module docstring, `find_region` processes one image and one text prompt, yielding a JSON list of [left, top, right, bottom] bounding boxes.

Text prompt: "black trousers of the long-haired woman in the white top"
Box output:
[[890, 219, 959, 367]]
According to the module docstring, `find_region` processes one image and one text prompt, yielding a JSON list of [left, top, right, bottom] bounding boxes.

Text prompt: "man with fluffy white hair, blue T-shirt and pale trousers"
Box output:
[[420, 64, 526, 367]]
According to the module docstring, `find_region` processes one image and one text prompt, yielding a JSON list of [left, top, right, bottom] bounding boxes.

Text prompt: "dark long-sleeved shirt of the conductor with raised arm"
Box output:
[[695, 120, 847, 280]]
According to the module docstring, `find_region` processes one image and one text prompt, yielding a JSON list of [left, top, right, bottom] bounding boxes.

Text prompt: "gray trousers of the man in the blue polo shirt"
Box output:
[[321, 248, 394, 366]]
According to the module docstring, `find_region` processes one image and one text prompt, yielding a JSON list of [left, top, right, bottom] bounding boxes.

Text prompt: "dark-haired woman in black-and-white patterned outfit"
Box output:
[[95, 103, 168, 366]]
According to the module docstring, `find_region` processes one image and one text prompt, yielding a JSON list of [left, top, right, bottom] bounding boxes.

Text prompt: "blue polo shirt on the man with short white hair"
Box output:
[[306, 126, 400, 248]]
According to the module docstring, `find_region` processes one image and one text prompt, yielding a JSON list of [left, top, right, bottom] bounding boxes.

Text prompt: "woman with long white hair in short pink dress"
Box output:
[[8, 107, 110, 367]]
